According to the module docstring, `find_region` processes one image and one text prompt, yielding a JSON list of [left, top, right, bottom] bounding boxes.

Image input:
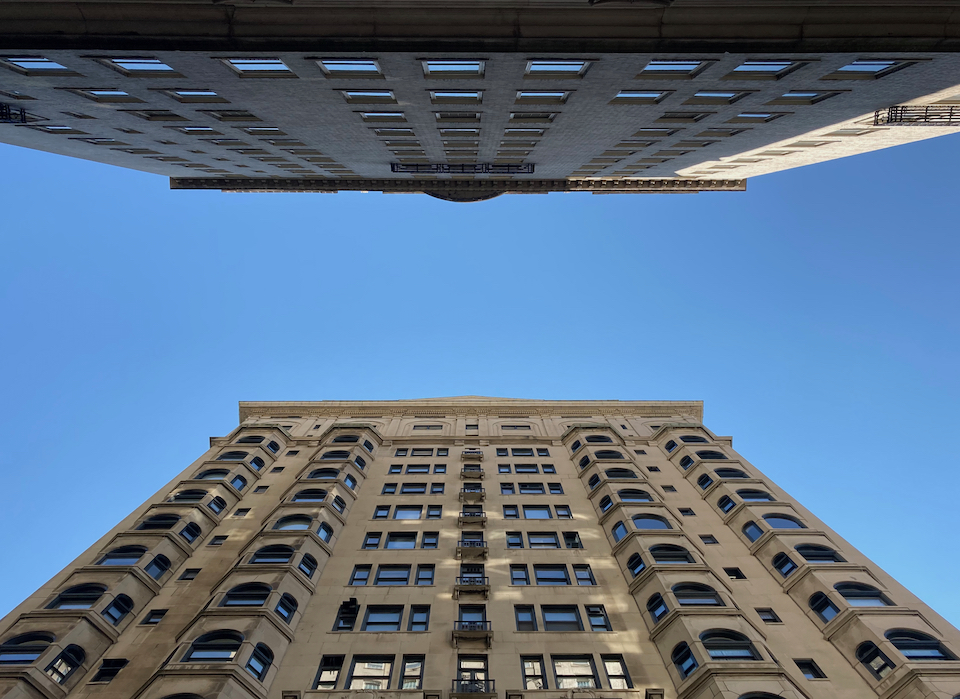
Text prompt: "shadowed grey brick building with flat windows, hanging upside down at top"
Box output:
[[0, 0, 960, 201]]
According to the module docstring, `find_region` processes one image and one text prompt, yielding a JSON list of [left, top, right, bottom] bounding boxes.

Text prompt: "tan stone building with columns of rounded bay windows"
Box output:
[[0, 397, 960, 699]]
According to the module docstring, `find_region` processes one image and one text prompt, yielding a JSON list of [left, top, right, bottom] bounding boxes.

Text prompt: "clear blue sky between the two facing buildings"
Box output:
[[0, 133, 960, 625]]
